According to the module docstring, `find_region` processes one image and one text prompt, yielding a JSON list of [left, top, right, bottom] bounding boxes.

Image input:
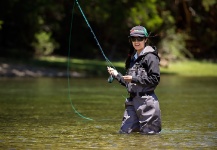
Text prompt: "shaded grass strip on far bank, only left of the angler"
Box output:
[[32, 56, 124, 76]]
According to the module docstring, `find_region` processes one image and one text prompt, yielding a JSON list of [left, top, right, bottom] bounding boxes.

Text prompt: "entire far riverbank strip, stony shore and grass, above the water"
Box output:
[[0, 56, 217, 77]]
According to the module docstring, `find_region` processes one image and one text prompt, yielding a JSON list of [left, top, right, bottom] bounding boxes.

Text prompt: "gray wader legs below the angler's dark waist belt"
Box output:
[[120, 93, 161, 134]]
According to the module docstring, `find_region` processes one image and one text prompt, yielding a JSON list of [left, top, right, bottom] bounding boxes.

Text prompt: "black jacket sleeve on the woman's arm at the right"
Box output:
[[132, 53, 160, 86]]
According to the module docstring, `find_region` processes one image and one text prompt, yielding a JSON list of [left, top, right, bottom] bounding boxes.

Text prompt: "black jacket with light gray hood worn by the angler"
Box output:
[[116, 46, 160, 93]]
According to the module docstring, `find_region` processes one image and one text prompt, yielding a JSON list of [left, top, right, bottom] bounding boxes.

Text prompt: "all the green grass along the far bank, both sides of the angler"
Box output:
[[33, 56, 217, 77]]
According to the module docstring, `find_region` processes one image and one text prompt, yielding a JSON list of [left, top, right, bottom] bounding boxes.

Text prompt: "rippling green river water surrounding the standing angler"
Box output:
[[0, 76, 217, 150]]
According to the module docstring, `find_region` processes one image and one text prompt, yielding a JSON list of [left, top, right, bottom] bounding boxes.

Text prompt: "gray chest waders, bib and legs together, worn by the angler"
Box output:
[[120, 52, 161, 134]]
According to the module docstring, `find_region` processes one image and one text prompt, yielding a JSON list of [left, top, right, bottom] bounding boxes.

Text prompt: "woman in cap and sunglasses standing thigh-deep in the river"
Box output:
[[107, 26, 161, 134]]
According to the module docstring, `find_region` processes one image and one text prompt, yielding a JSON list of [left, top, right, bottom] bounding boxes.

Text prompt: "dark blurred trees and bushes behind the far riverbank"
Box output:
[[0, 0, 217, 62]]
